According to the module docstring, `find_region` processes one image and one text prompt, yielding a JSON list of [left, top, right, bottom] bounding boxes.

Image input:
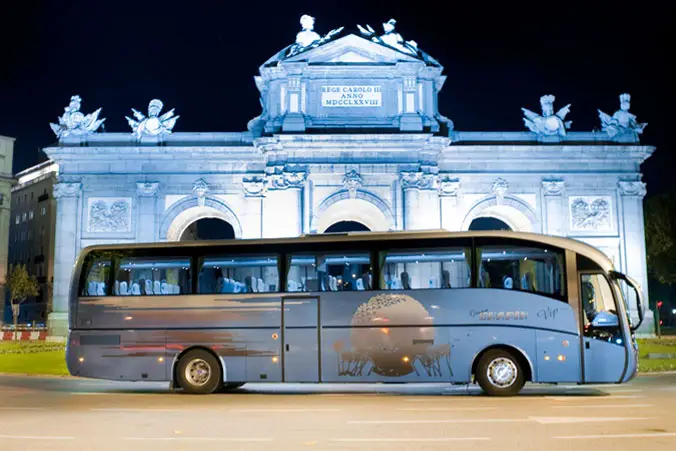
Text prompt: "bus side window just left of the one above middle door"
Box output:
[[197, 255, 279, 294]]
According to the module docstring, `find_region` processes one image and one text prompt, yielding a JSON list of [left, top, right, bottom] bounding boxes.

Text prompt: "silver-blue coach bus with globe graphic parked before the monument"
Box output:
[[66, 231, 645, 396]]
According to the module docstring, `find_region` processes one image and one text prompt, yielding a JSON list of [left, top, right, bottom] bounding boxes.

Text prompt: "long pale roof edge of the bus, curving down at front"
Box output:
[[83, 229, 614, 271]]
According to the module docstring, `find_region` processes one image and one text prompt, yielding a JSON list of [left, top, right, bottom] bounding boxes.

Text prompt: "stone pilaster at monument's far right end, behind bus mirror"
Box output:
[[617, 181, 654, 334]]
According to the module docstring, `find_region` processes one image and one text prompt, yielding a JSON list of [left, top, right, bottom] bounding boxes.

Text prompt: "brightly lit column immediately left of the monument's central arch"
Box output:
[[263, 172, 306, 238]]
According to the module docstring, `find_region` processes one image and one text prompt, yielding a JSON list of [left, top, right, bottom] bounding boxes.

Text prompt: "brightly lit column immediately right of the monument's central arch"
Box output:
[[401, 172, 441, 230]]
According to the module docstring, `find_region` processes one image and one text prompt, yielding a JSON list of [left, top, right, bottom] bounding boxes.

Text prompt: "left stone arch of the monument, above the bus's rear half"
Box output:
[[160, 196, 242, 241]]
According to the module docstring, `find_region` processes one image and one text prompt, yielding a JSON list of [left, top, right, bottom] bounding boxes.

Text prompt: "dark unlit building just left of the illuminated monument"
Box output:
[[4, 161, 58, 324]]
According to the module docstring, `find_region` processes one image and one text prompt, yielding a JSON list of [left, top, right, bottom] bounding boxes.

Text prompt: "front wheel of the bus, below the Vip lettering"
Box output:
[[474, 349, 526, 396]]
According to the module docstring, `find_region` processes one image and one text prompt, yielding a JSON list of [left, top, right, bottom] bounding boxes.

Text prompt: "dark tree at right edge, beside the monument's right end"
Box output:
[[645, 193, 676, 285]]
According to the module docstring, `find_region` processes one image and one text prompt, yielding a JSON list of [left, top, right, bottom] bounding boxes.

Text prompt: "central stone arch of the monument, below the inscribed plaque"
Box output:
[[310, 190, 394, 233]]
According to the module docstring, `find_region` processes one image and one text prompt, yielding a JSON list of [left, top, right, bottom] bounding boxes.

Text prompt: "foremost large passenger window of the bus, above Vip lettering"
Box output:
[[477, 244, 566, 300]]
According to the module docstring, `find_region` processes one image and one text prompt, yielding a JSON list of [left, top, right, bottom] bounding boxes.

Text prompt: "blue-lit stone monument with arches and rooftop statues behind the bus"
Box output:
[[45, 16, 654, 333]]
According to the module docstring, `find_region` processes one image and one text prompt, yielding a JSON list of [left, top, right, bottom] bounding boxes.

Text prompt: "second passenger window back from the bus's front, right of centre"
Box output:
[[380, 248, 471, 290]]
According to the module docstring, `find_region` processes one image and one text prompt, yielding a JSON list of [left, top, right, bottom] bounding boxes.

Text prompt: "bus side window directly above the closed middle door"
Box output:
[[286, 252, 373, 291]]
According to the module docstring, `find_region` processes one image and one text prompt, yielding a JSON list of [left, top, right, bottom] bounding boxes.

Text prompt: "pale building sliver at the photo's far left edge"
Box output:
[[0, 135, 14, 324]]
